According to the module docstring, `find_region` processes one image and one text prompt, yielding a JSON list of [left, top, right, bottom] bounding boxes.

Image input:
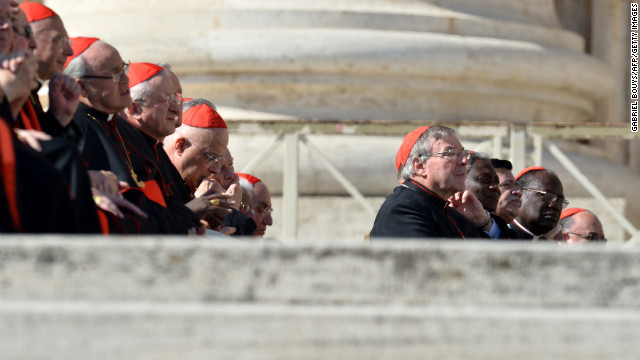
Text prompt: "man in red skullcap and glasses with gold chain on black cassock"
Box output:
[[65, 38, 202, 234]]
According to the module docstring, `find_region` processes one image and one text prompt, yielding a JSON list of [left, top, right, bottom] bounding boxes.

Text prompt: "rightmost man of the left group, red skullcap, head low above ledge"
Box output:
[[238, 173, 273, 236]]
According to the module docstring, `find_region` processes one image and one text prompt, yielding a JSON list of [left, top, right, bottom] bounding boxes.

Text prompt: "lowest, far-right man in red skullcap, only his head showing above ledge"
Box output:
[[560, 208, 607, 244]]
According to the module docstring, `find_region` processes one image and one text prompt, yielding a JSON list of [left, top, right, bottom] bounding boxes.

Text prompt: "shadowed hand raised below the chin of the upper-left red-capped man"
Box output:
[[49, 72, 80, 127]]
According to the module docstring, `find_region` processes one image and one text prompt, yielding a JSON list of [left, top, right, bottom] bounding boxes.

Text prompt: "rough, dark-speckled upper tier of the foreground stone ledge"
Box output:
[[0, 236, 640, 309]]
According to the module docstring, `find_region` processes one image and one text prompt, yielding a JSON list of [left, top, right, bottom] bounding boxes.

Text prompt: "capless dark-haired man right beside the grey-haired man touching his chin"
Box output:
[[465, 152, 517, 239]]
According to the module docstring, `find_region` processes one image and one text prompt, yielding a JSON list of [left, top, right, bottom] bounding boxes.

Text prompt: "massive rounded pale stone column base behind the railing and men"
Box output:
[[47, 0, 613, 194]]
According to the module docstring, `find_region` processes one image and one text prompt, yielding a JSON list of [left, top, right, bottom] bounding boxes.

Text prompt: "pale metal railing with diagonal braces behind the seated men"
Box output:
[[227, 119, 640, 242]]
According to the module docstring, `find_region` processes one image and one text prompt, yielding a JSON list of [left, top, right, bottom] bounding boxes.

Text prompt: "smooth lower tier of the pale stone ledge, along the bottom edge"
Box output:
[[0, 301, 640, 360]]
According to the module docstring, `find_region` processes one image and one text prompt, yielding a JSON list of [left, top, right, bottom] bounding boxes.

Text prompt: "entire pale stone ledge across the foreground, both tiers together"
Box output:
[[0, 235, 640, 360]]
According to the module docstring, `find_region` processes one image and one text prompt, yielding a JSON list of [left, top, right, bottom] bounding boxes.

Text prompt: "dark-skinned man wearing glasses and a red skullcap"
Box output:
[[509, 167, 569, 241]]
